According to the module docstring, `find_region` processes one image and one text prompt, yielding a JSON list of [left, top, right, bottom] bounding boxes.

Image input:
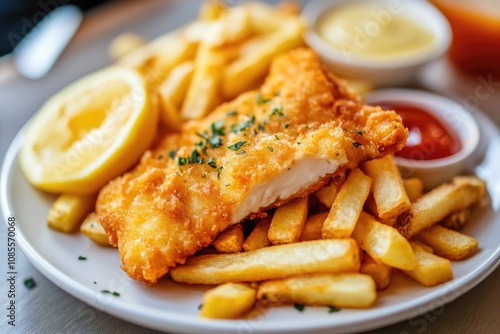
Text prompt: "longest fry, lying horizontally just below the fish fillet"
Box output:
[[170, 239, 360, 284]]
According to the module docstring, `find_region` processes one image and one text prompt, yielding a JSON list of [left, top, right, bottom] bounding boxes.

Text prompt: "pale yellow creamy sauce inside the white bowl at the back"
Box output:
[[316, 2, 434, 59]]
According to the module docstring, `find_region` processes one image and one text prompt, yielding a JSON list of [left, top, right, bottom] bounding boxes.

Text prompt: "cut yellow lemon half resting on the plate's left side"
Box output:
[[19, 67, 158, 194]]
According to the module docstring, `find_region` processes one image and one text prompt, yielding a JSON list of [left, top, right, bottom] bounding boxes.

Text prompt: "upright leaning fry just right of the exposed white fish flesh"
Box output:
[[321, 168, 372, 239]]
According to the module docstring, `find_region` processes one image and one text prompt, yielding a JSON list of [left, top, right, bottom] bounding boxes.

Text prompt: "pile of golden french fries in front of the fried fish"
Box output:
[[170, 155, 485, 318]]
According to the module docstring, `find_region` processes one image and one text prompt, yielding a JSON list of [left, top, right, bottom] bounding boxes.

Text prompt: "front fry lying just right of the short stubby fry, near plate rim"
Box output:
[[257, 273, 377, 308]]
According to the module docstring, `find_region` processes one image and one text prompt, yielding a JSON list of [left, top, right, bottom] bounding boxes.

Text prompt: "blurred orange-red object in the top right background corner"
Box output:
[[432, 0, 500, 80]]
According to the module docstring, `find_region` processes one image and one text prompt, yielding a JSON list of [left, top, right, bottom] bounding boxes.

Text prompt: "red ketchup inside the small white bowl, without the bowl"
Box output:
[[382, 102, 461, 160]]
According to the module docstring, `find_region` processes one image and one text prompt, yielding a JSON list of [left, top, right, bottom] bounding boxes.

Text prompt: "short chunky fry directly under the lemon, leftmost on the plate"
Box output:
[[47, 194, 97, 233]]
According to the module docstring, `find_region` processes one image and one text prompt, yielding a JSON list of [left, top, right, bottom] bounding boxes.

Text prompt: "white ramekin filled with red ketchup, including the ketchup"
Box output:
[[364, 89, 480, 189]]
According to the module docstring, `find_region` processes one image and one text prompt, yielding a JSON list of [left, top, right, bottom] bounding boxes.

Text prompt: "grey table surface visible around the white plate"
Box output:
[[0, 0, 500, 334]]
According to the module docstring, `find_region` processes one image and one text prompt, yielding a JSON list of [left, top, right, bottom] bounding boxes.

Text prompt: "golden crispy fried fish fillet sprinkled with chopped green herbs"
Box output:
[[96, 49, 408, 283]]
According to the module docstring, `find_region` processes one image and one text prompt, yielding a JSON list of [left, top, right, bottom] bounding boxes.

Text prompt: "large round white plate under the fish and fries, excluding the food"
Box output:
[[1, 108, 500, 333]]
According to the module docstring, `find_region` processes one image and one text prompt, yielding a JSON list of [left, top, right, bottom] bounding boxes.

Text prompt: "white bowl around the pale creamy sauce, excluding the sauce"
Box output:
[[302, 0, 451, 86]]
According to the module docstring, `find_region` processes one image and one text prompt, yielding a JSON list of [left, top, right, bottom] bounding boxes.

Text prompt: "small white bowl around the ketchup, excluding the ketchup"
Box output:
[[364, 89, 480, 189]]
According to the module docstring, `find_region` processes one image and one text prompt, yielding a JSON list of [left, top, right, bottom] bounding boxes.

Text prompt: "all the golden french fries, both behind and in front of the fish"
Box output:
[[44, 2, 485, 319]]
